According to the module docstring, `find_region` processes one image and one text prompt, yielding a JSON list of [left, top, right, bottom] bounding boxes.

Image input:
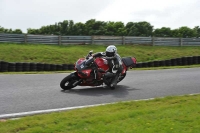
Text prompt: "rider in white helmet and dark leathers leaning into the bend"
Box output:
[[93, 45, 123, 89]]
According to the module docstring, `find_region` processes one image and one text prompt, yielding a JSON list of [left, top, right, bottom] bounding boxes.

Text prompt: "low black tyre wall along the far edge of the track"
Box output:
[[0, 56, 200, 72]]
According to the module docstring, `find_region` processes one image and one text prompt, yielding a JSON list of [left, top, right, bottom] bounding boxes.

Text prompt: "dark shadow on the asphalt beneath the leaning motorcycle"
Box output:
[[61, 85, 138, 98]]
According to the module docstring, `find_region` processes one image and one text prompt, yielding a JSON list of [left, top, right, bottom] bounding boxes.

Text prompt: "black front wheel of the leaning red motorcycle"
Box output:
[[60, 73, 79, 90]]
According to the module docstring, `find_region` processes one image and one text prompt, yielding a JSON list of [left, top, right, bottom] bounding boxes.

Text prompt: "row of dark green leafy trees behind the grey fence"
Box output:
[[0, 19, 200, 38]]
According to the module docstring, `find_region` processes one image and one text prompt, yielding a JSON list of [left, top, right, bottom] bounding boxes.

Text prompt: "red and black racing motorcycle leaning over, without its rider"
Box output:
[[60, 51, 136, 90]]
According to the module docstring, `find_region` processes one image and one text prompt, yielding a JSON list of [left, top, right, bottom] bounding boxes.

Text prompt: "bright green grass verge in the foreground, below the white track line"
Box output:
[[0, 94, 200, 133]]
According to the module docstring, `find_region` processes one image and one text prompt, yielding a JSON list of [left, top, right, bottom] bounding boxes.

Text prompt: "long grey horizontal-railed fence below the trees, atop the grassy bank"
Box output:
[[0, 33, 200, 46]]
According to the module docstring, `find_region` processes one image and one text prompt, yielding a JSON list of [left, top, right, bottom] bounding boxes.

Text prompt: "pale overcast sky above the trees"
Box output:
[[0, 0, 200, 33]]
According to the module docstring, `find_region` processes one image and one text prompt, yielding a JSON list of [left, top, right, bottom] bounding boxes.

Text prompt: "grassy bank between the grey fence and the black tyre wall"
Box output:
[[0, 43, 200, 64]]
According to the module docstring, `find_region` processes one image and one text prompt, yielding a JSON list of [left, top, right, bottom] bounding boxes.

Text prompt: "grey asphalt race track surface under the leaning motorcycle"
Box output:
[[0, 68, 200, 116]]
